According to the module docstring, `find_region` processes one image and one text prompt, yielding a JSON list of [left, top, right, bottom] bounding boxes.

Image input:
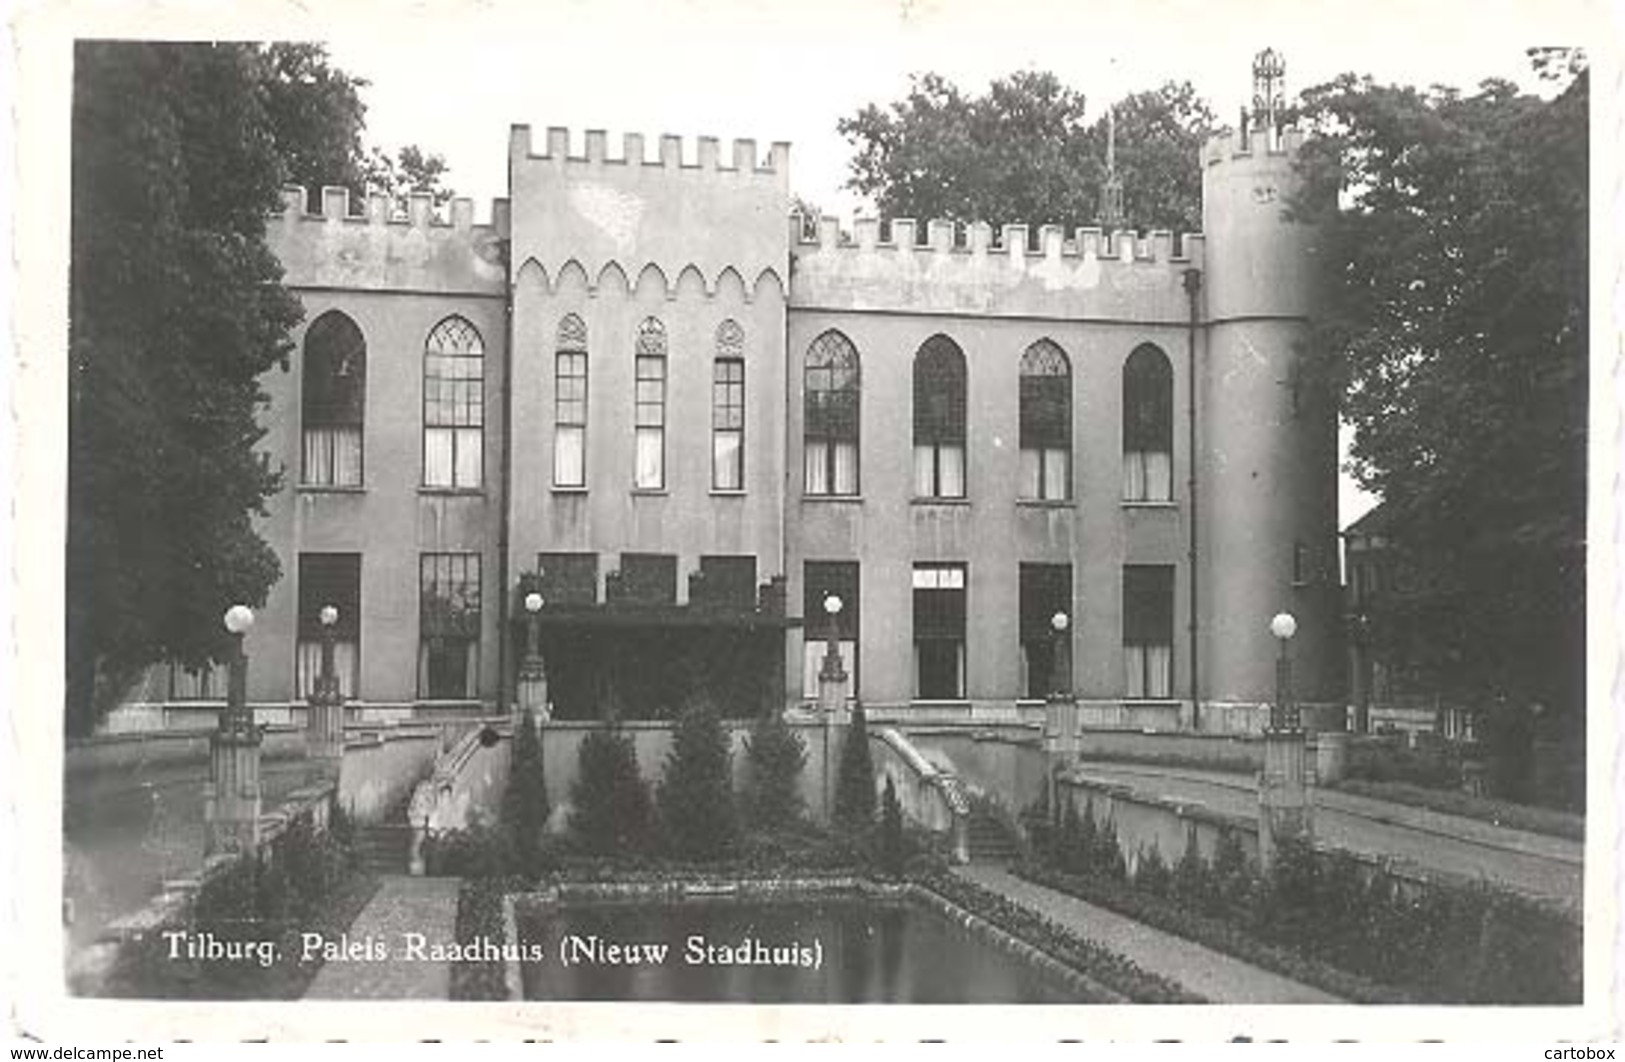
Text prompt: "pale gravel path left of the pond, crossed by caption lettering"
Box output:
[[306, 875, 463, 999]]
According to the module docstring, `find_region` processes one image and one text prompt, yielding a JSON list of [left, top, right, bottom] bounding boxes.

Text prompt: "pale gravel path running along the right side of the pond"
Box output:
[[954, 864, 1346, 1004]]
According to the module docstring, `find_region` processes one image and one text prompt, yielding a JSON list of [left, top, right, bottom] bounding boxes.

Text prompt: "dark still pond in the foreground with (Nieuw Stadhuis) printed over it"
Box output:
[[517, 898, 1087, 1004]]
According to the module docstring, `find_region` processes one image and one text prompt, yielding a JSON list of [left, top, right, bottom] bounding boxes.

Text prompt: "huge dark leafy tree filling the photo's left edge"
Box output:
[[67, 42, 301, 732]]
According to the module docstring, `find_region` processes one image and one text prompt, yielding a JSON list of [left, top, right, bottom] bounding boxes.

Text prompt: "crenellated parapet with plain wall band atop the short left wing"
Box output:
[[267, 187, 509, 294]]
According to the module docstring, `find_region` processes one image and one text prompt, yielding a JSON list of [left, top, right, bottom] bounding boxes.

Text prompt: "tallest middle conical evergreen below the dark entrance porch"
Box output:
[[660, 697, 739, 859]]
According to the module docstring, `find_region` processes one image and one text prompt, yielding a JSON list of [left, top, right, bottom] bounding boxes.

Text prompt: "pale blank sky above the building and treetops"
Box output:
[[322, 0, 1607, 525]]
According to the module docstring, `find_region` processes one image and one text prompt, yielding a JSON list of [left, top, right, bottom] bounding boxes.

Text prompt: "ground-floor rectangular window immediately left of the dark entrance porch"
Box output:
[[418, 554, 479, 700]]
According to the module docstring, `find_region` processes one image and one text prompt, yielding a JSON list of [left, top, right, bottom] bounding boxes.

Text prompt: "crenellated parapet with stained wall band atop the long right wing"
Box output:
[[790, 218, 1206, 322]]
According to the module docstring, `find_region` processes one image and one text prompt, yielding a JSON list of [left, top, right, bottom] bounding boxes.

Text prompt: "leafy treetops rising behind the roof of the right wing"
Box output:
[[837, 71, 1214, 235]]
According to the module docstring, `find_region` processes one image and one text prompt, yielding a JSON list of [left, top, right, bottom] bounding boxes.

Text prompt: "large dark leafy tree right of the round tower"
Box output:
[[1292, 50, 1589, 734]]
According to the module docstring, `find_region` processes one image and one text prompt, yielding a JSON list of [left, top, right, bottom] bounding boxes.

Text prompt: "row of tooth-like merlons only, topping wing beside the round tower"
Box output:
[[790, 214, 1203, 265]]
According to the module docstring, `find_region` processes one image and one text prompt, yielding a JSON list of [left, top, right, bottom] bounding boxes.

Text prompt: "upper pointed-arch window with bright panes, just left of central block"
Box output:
[[423, 317, 486, 490]]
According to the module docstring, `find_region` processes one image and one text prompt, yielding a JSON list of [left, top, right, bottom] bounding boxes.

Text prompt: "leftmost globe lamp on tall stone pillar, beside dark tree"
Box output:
[[203, 604, 260, 856]]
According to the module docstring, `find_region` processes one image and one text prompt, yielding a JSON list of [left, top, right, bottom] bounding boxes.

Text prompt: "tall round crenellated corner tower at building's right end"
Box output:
[[1198, 125, 1344, 729]]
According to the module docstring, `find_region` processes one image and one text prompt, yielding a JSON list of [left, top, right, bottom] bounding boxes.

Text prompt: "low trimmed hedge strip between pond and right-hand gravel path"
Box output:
[[913, 870, 1207, 1004]]
